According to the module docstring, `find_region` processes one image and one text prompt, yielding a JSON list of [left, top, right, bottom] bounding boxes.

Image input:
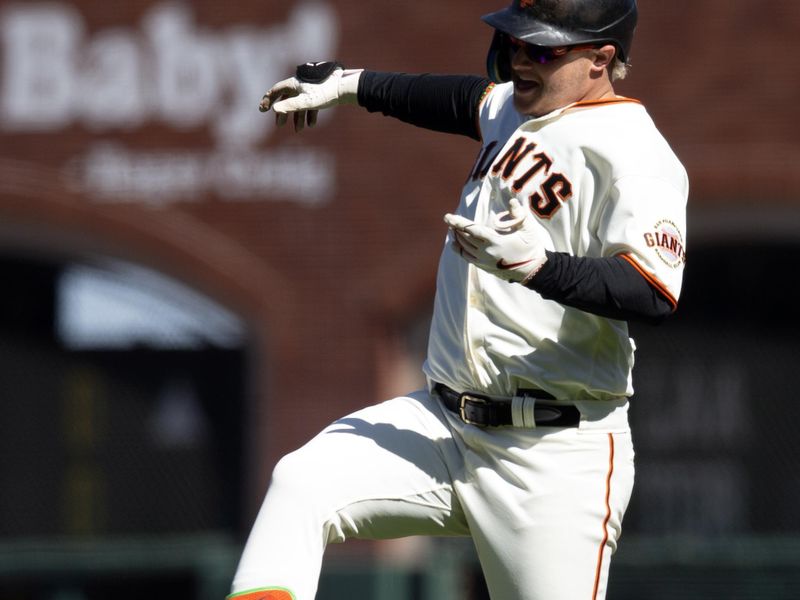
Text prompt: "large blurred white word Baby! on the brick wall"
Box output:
[[0, 1, 338, 147]]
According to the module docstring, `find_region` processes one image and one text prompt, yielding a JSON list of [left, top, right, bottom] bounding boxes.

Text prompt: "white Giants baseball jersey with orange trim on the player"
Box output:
[[424, 83, 688, 400]]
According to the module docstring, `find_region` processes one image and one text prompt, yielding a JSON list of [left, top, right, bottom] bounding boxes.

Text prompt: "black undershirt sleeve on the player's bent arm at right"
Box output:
[[527, 251, 675, 325]]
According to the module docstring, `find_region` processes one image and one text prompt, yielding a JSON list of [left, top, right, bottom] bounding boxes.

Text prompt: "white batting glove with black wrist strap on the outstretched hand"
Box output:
[[258, 62, 363, 131]]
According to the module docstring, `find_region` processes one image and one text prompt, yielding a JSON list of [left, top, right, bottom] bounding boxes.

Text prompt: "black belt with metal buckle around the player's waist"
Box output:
[[433, 383, 581, 427]]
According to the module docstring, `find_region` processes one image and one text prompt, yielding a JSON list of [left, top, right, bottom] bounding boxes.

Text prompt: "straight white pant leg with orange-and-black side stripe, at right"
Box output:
[[456, 422, 634, 600]]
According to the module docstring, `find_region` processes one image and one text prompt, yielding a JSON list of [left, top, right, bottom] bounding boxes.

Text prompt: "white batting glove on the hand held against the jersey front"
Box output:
[[444, 198, 547, 284]]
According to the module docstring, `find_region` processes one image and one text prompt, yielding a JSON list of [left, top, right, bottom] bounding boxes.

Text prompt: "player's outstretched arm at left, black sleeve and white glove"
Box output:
[[259, 62, 491, 140]]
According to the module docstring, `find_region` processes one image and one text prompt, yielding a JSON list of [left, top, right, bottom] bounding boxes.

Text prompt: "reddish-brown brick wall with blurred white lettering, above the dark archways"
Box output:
[[0, 0, 800, 516]]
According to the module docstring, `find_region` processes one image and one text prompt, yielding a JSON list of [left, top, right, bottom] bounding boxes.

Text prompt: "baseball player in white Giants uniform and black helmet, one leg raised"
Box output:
[[231, 0, 688, 600]]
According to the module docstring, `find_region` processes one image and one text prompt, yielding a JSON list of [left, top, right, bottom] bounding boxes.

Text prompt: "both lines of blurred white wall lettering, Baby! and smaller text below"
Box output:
[[0, 0, 338, 206]]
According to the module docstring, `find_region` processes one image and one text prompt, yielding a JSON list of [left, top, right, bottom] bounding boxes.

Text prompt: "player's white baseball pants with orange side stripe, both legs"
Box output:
[[232, 390, 634, 600]]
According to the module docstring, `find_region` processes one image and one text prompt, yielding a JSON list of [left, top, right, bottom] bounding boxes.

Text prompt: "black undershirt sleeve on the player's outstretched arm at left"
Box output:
[[358, 71, 491, 140]]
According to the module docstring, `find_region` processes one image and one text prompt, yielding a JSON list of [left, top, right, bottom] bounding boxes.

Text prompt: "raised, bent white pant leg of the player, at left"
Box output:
[[232, 391, 468, 600]]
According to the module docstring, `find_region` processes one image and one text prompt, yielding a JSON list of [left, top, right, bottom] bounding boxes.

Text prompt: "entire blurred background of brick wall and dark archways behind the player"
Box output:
[[0, 0, 800, 600]]
